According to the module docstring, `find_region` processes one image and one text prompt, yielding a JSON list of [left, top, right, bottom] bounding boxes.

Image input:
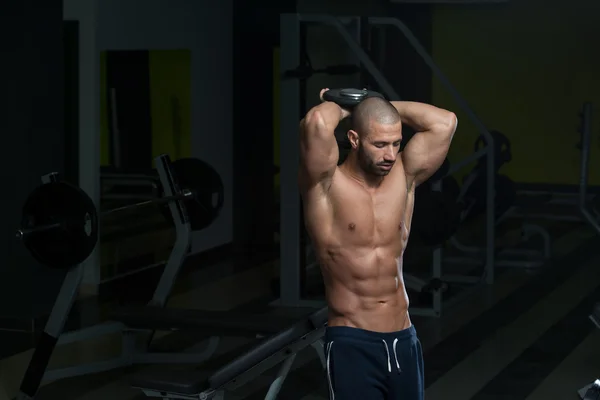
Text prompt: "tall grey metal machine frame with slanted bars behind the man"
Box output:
[[278, 14, 495, 316]]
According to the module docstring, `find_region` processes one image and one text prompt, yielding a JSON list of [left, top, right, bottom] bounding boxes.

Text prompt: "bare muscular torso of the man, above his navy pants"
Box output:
[[303, 157, 414, 332]]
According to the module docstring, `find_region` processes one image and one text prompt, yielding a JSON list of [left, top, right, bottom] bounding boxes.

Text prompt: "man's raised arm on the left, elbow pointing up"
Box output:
[[300, 96, 349, 190]]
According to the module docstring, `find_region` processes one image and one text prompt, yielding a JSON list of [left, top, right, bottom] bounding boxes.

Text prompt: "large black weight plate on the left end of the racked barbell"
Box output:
[[22, 182, 98, 269]]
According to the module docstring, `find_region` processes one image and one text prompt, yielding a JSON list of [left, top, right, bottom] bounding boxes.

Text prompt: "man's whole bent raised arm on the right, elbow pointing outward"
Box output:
[[391, 101, 458, 188]]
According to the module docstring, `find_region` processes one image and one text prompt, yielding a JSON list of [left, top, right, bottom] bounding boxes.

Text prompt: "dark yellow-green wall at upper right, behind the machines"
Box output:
[[432, 0, 600, 184]]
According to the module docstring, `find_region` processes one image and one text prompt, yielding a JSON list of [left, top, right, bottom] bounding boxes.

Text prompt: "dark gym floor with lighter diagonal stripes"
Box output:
[[0, 228, 600, 400]]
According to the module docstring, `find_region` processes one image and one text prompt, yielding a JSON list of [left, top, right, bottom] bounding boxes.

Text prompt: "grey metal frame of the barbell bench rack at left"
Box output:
[[17, 156, 199, 400]]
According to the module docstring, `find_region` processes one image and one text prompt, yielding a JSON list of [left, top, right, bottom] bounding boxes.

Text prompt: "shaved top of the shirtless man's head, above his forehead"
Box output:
[[352, 97, 400, 136]]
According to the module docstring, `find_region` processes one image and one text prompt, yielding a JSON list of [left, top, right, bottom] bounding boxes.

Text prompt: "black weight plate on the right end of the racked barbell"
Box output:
[[161, 158, 224, 231]]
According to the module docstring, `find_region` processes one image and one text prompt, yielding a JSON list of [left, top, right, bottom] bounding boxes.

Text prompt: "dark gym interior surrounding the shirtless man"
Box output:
[[0, 0, 600, 400]]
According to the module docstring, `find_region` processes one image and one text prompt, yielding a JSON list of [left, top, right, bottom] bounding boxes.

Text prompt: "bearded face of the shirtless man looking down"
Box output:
[[357, 122, 402, 176]]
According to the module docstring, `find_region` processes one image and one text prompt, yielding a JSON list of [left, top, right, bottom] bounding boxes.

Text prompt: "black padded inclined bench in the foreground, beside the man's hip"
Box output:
[[130, 307, 328, 400]]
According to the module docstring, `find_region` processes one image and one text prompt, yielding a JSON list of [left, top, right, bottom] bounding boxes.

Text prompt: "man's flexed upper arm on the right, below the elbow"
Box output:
[[401, 132, 451, 186]]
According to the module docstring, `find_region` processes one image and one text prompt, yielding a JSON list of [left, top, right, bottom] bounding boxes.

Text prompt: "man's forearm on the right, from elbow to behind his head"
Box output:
[[391, 101, 456, 132]]
